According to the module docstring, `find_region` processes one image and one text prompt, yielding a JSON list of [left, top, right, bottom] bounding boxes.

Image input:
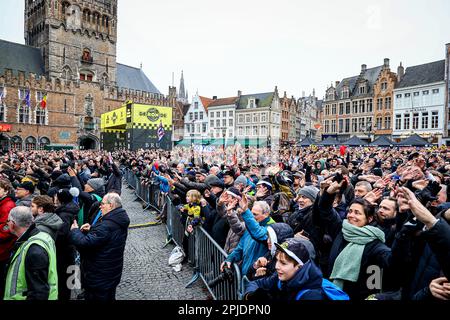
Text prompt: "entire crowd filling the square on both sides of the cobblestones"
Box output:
[[0, 146, 450, 300]]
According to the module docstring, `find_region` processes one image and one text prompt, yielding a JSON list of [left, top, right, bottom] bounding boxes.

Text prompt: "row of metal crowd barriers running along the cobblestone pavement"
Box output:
[[125, 170, 242, 300]]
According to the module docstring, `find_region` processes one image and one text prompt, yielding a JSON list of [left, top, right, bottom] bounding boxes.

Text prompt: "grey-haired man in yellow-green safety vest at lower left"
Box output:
[[4, 206, 58, 300]]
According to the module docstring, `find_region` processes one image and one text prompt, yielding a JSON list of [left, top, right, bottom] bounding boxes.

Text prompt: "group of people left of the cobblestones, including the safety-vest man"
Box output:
[[0, 151, 130, 300]]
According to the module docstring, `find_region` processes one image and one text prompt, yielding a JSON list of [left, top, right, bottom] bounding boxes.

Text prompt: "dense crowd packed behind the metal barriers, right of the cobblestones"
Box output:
[[116, 147, 450, 300]]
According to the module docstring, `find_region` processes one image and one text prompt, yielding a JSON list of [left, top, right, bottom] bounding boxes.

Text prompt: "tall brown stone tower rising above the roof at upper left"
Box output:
[[24, 0, 117, 85]]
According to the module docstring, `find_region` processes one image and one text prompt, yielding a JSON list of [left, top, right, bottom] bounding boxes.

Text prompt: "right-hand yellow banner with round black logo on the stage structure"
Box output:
[[132, 104, 172, 130]]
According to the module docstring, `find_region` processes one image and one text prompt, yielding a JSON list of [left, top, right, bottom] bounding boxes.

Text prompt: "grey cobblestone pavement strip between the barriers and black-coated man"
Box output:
[[116, 184, 209, 300]]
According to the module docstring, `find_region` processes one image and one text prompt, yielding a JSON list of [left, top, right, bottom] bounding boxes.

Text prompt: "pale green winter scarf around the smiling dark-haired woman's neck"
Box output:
[[330, 219, 385, 289]]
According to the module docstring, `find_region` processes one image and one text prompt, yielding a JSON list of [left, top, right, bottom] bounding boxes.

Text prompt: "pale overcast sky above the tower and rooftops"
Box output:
[[0, 0, 450, 97]]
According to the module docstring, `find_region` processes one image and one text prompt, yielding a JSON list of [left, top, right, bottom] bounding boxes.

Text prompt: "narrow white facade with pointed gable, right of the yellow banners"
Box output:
[[183, 94, 209, 140]]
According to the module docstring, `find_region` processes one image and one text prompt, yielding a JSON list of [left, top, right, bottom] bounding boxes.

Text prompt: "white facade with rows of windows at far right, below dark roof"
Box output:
[[392, 81, 446, 139]]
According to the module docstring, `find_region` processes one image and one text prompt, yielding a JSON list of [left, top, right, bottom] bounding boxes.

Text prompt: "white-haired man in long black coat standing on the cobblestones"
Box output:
[[70, 193, 130, 300]]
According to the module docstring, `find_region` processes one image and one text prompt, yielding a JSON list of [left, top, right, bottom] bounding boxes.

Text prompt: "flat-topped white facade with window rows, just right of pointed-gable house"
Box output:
[[208, 104, 236, 139]]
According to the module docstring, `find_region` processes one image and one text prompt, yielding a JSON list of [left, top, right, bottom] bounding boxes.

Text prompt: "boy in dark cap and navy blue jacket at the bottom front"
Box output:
[[244, 238, 328, 301]]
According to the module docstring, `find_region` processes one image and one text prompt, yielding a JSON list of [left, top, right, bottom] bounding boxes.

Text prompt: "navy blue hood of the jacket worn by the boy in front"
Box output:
[[278, 260, 323, 294]]
